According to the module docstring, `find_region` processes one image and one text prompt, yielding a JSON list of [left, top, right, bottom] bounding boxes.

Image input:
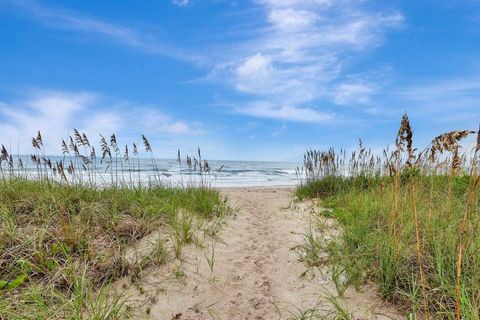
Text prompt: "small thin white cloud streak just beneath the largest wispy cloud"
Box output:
[[236, 102, 334, 123]]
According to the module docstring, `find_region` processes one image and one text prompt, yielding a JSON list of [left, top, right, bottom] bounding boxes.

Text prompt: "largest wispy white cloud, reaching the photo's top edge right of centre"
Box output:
[[210, 0, 403, 122]]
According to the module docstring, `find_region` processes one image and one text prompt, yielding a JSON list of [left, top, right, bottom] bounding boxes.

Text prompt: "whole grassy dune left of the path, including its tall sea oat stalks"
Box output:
[[0, 130, 229, 320]]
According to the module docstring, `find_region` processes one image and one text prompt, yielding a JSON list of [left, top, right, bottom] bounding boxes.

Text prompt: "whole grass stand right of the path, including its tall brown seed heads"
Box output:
[[296, 115, 480, 319]]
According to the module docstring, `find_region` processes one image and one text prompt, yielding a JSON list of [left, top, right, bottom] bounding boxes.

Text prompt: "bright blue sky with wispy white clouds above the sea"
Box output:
[[0, 0, 480, 161]]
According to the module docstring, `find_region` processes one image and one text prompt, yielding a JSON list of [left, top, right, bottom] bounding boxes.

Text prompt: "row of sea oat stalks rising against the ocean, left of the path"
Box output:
[[0, 129, 216, 188]]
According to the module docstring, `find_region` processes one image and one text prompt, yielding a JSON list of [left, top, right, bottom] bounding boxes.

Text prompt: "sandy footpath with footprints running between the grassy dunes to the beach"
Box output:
[[117, 188, 400, 320]]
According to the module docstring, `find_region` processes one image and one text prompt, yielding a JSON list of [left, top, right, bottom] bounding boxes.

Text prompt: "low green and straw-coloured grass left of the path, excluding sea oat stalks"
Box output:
[[0, 178, 229, 319]]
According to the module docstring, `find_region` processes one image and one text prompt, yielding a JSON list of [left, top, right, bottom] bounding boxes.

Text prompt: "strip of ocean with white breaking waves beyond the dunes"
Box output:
[[9, 156, 301, 187]]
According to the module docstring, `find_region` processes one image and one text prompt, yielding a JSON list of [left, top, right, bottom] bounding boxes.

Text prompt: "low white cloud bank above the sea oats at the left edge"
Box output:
[[0, 90, 204, 154]]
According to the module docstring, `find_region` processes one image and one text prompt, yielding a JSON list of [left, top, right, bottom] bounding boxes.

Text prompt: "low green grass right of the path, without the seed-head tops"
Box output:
[[316, 177, 480, 319]]
